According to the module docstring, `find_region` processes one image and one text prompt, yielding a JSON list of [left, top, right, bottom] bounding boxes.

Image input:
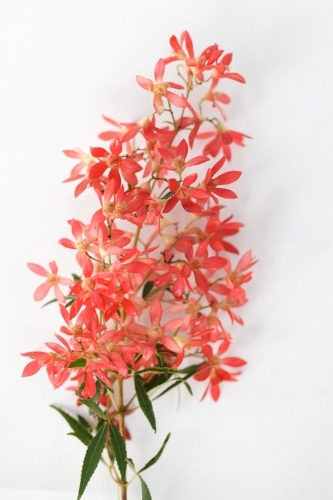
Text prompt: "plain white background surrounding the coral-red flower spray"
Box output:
[[0, 0, 333, 500]]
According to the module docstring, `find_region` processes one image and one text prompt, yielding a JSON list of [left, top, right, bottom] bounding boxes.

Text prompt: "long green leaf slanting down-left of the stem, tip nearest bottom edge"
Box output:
[[77, 423, 107, 500]]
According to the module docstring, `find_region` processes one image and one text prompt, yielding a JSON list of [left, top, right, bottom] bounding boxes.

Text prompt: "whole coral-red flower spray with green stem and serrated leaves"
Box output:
[[23, 31, 255, 500]]
